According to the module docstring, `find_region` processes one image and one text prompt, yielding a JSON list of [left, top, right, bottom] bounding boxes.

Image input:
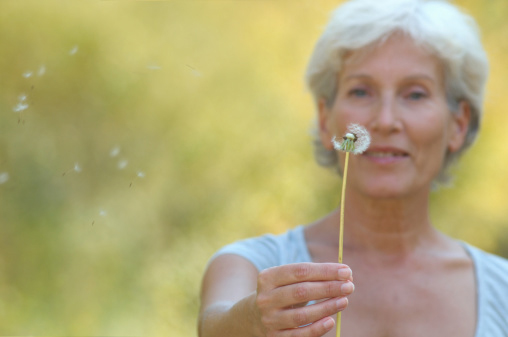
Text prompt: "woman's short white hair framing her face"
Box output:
[[306, 0, 488, 183]]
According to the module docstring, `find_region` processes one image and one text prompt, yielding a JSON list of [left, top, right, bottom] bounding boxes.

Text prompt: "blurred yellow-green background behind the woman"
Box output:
[[0, 0, 508, 337]]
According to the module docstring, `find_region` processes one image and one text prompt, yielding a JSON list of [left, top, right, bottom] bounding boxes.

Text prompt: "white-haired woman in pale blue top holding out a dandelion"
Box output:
[[199, 0, 508, 337]]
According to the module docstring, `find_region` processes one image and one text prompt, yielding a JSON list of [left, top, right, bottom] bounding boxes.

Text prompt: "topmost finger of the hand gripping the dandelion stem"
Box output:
[[258, 263, 352, 289]]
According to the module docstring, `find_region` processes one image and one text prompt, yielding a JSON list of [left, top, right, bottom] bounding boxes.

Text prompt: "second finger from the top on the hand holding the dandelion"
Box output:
[[271, 281, 354, 308]]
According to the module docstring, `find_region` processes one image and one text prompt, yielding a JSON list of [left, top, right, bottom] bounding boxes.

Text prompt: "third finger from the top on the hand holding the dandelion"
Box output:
[[274, 297, 348, 329]]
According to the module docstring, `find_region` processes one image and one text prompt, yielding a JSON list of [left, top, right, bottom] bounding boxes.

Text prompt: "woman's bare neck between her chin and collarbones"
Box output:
[[316, 188, 442, 256]]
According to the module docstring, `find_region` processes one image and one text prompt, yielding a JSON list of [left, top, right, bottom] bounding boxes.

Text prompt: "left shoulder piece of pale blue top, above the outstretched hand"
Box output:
[[208, 226, 310, 271]]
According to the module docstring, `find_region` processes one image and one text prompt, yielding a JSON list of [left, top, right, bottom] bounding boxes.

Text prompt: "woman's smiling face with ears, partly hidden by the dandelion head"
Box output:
[[320, 35, 469, 198]]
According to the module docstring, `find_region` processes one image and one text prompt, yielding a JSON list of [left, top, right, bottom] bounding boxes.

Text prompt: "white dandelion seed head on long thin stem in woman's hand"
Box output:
[[332, 124, 370, 337]]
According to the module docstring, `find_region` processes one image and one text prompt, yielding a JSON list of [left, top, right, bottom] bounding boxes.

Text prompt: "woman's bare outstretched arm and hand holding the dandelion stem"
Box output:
[[199, 255, 354, 337]]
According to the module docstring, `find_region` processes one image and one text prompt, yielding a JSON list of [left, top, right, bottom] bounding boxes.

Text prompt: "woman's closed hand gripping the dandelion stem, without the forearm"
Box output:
[[256, 263, 354, 337]]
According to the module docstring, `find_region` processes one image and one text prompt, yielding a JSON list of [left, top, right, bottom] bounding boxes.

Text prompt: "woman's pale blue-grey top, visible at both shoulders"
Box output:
[[212, 226, 508, 337]]
